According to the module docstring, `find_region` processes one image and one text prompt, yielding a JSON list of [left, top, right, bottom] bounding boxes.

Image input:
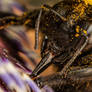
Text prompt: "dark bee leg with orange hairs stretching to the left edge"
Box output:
[[0, 9, 39, 29]]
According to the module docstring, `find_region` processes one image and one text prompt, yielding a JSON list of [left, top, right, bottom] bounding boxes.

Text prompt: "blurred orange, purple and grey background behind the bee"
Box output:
[[0, 0, 60, 75]]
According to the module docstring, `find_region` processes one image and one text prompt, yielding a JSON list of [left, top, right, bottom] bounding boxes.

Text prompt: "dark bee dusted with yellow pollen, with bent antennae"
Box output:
[[0, 0, 92, 87]]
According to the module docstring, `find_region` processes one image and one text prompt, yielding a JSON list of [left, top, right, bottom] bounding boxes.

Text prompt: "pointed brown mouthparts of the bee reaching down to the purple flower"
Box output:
[[31, 53, 53, 78]]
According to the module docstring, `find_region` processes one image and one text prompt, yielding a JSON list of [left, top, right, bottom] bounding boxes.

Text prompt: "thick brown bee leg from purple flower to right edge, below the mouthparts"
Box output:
[[35, 67, 92, 92]]
